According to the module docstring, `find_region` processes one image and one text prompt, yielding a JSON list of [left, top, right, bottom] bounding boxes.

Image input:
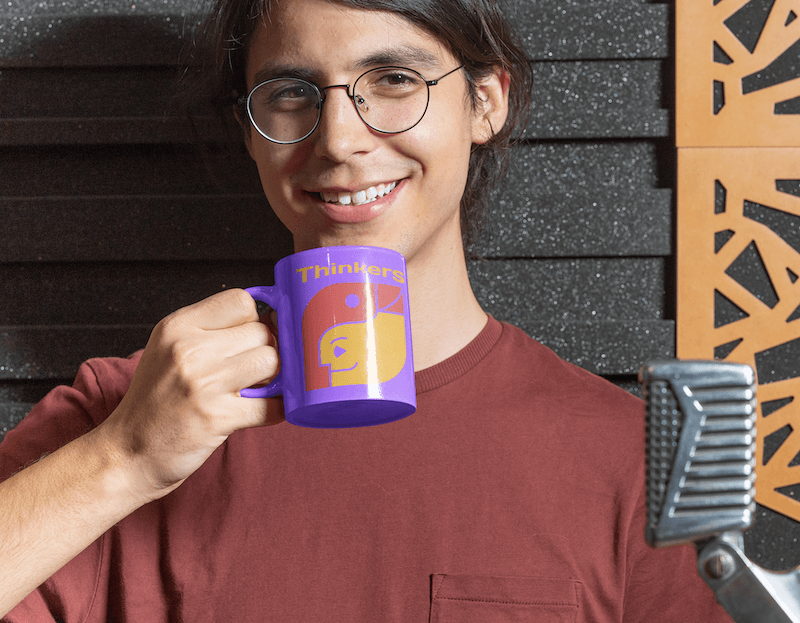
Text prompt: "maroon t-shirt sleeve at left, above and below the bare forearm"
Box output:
[[0, 357, 138, 623]]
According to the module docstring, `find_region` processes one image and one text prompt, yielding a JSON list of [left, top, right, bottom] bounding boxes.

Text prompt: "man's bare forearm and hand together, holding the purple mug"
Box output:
[[0, 290, 283, 618]]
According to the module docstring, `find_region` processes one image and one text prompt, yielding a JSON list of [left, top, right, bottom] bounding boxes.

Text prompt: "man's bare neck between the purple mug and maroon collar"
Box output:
[[407, 239, 488, 370]]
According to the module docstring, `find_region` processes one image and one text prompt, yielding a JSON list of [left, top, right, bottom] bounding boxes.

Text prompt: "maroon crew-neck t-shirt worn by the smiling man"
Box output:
[[0, 319, 730, 623]]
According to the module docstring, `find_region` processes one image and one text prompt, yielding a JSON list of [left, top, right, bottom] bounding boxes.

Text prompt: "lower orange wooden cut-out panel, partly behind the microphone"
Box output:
[[677, 148, 800, 521]]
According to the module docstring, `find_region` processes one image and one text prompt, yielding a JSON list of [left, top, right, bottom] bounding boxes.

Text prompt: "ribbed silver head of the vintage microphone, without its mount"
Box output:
[[639, 361, 756, 547]]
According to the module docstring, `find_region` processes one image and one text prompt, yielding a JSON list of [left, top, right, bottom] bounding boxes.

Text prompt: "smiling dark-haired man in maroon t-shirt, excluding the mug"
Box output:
[[0, 0, 726, 623]]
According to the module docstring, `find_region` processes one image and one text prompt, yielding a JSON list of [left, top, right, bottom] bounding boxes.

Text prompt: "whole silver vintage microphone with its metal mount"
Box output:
[[639, 360, 800, 623]]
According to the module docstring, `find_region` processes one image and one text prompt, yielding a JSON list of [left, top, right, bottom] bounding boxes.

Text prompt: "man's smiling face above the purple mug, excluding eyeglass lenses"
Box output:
[[242, 0, 505, 260]]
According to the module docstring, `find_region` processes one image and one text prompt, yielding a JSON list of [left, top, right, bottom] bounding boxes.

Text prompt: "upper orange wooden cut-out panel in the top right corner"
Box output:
[[675, 0, 800, 147]]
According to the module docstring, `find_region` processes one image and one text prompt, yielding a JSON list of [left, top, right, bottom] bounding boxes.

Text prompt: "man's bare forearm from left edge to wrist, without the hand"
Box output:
[[0, 431, 147, 617]]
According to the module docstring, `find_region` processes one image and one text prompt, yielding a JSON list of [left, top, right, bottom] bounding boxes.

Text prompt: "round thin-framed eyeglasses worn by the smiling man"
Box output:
[[239, 65, 463, 144]]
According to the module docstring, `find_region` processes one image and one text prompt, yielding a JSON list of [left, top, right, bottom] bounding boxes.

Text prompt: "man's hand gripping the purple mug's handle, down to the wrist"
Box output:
[[96, 290, 283, 500]]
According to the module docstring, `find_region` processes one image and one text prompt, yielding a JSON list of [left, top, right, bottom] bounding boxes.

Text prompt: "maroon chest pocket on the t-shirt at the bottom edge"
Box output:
[[430, 574, 581, 623]]
